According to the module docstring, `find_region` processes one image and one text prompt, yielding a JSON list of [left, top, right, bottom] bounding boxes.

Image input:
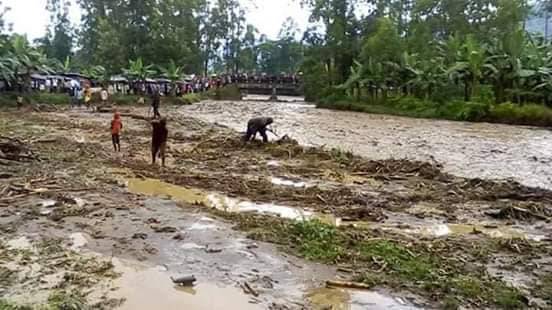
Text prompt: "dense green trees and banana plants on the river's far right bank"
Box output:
[[303, 0, 552, 104]]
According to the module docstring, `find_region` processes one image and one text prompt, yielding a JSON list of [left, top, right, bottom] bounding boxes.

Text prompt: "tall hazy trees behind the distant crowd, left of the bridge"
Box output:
[[33, 0, 302, 75]]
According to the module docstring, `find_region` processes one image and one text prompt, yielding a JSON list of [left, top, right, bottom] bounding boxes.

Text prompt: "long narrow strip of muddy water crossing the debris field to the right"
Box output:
[[126, 178, 546, 241]]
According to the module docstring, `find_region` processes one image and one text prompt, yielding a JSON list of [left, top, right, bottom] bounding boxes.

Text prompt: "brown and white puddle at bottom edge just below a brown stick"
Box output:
[[306, 288, 419, 310]]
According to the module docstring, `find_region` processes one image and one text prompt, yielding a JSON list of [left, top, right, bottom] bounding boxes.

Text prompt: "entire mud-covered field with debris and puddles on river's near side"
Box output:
[[0, 108, 552, 309]]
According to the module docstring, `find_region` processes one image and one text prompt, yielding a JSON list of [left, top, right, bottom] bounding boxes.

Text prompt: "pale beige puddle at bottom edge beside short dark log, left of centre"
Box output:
[[112, 259, 263, 310]]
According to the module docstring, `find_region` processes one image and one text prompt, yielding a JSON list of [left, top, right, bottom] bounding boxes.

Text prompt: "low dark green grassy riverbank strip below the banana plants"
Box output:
[[317, 97, 552, 127]]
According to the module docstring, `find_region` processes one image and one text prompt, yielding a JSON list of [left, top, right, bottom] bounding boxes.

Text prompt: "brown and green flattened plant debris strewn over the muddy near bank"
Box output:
[[0, 111, 552, 309]]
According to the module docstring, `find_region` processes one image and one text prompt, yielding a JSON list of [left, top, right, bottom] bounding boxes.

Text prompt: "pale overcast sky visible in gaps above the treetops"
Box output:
[[2, 0, 309, 40]]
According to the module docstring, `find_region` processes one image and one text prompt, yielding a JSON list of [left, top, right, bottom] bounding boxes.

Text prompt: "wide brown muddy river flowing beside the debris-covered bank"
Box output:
[[181, 101, 552, 189]]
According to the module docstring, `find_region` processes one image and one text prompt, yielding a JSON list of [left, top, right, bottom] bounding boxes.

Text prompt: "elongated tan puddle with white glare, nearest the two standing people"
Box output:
[[128, 179, 313, 220]]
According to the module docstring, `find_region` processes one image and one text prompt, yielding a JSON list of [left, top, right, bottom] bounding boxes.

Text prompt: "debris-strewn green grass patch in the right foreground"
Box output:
[[220, 211, 532, 309]]
